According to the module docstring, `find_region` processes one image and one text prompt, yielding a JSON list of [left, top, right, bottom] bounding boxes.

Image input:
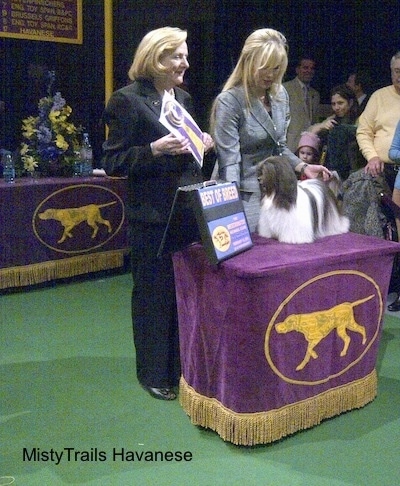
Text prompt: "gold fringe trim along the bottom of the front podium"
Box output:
[[179, 370, 378, 446]]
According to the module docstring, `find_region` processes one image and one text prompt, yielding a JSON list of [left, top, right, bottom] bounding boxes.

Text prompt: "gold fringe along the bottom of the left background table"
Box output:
[[0, 250, 127, 289]]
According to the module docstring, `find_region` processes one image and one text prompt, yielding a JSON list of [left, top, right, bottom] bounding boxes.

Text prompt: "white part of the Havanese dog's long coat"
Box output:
[[258, 179, 350, 243]]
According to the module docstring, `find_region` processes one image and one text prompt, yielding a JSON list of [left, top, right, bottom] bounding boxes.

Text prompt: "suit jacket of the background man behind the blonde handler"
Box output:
[[283, 78, 320, 152]]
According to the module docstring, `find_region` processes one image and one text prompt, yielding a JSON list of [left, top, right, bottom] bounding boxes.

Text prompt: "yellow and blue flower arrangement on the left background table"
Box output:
[[20, 71, 82, 176]]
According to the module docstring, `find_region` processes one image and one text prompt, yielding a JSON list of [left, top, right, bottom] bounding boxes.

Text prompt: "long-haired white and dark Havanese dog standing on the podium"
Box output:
[[257, 156, 350, 243]]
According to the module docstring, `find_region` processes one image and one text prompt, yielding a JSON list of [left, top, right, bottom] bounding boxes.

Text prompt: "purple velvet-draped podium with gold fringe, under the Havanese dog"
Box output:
[[174, 233, 399, 445]]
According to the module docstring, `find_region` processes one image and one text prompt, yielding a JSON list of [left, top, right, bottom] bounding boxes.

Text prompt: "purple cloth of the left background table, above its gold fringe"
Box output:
[[0, 177, 128, 269]]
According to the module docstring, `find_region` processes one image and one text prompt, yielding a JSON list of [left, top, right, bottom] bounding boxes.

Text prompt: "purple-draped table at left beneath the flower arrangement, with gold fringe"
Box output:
[[0, 177, 128, 289]]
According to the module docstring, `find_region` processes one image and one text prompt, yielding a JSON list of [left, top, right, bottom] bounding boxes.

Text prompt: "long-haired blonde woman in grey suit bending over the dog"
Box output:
[[211, 29, 330, 231]]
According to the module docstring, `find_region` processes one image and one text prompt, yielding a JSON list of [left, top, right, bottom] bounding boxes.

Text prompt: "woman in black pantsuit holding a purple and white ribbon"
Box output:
[[102, 27, 213, 400]]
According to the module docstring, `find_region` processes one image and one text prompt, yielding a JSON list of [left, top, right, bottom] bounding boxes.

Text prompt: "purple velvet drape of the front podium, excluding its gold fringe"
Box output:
[[174, 233, 400, 413]]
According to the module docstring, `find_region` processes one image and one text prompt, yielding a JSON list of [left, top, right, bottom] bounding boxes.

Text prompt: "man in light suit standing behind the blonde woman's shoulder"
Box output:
[[283, 57, 320, 152]]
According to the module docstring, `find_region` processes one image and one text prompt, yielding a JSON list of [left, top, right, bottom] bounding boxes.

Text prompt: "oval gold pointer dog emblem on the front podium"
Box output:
[[265, 270, 383, 384]]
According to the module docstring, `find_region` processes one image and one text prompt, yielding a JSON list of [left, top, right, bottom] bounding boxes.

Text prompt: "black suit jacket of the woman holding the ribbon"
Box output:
[[102, 80, 203, 224]]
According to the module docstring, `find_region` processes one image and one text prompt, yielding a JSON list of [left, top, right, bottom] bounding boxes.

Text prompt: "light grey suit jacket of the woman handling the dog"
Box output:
[[214, 87, 301, 192]]
